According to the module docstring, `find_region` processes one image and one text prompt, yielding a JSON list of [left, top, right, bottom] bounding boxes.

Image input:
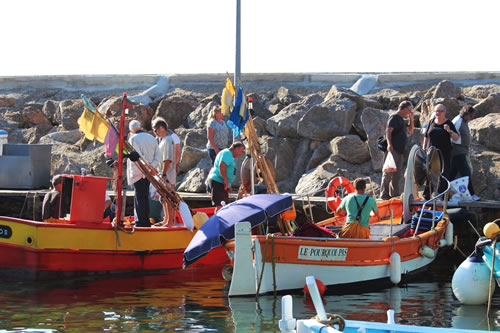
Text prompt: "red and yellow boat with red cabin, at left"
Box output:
[[0, 96, 228, 279]]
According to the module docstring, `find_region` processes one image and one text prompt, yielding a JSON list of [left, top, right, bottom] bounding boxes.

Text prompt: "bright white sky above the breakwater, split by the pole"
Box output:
[[0, 0, 500, 76]]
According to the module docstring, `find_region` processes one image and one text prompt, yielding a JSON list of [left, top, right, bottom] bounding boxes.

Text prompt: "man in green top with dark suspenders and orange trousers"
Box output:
[[336, 178, 377, 239]]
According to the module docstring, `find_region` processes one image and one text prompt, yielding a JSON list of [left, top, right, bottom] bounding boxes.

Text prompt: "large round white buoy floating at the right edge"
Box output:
[[451, 249, 495, 305]]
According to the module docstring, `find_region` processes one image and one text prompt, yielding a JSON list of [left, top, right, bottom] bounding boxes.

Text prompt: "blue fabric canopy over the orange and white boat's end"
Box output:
[[184, 194, 292, 267]]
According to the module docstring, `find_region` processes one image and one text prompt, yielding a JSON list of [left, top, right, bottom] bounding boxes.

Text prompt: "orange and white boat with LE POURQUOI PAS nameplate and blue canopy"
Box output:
[[184, 144, 453, 296]]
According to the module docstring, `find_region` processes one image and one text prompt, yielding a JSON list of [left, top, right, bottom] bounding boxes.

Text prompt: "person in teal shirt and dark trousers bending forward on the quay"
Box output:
[[207, 141, 245, 209]]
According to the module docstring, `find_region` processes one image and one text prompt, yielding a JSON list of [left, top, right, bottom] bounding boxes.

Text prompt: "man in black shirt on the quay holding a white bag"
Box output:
[[380, 101, 415, 200]]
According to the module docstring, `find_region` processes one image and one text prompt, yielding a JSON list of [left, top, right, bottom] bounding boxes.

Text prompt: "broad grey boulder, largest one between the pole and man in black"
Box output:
[[296, 98, 357, 141]]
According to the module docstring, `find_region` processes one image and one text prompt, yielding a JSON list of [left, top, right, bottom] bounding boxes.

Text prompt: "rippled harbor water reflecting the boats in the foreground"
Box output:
[[0, 250, 500, 333]]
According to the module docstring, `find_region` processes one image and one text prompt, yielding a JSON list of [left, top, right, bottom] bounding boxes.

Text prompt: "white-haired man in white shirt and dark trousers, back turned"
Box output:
[[127, 120, 160, 227]]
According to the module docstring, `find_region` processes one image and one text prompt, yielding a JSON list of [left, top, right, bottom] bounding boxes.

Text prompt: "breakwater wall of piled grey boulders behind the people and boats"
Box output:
[[0, 75, 500, 199]]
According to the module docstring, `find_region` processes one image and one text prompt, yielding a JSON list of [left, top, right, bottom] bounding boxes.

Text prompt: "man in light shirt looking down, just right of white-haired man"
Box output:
[[153, 117, 177, 226]]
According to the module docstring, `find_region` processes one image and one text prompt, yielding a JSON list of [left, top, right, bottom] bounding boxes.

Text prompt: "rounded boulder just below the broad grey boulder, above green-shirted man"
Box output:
[[330, 135, 370, 164]]
